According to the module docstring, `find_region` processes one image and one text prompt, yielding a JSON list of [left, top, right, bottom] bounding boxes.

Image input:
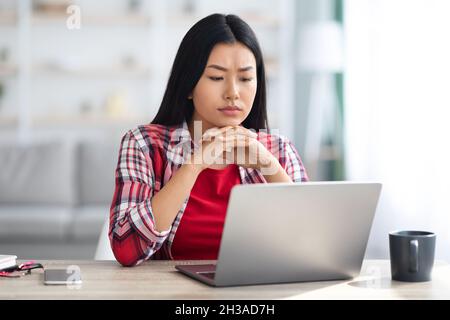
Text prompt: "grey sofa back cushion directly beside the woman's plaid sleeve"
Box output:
[[78, 141, 119, 206]]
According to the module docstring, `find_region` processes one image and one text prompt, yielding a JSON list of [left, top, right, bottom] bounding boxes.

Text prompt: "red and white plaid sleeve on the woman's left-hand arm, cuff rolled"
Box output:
[[109, 131, 170, 266]]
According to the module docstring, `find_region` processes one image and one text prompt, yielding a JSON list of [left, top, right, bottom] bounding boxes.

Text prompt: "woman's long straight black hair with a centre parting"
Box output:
[[151, 13, 269, 130]]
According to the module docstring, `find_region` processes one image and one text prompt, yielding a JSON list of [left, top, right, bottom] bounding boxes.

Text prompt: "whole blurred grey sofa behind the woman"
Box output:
[[0, 140, 119, 259]]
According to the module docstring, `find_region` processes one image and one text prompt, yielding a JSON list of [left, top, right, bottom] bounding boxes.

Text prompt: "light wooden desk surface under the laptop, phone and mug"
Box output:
[[0, 260, 450, 299]]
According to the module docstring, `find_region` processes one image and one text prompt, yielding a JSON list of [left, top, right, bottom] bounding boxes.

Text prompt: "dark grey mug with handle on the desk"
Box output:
[[389, 231, 436, 282]]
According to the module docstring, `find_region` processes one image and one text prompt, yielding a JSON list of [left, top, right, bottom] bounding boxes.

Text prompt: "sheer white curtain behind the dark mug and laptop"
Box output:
[[344, 0, 450, 261]]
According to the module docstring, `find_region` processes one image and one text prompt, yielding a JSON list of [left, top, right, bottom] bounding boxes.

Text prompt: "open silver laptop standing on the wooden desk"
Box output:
[[176, 182, 381, 286]]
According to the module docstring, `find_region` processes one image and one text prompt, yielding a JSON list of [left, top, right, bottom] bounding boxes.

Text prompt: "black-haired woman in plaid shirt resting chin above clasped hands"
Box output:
[[109, 14, 308, 266]]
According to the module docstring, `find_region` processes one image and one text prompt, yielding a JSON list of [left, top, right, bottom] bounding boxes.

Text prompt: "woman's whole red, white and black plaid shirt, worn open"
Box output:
[[109, 122, 308, 266]]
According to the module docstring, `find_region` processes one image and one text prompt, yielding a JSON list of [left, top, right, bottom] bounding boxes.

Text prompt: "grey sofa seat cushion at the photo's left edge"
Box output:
[[0, 206, 72, 242]]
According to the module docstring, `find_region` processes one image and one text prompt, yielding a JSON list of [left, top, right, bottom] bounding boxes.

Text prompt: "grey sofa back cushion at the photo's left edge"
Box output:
[[0, 142, 77, 205]]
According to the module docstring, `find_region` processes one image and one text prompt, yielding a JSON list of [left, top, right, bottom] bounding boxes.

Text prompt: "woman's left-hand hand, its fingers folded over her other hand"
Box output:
[[187, 126, 257, 171]]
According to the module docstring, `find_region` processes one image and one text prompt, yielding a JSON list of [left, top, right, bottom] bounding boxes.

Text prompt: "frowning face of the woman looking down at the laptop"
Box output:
[[190, 42, 257, 131]]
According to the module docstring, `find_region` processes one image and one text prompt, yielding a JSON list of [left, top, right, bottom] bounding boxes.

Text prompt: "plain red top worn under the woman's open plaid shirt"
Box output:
[[171, 164, 241, 260]]
